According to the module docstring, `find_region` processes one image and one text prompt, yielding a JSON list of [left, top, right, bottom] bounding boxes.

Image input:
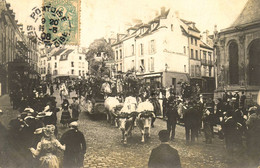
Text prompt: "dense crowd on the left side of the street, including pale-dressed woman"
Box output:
[[0, 83, 86, 168]]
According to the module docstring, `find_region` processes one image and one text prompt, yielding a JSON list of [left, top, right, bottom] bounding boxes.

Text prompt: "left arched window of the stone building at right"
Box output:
[[228, 41, 239, 84]]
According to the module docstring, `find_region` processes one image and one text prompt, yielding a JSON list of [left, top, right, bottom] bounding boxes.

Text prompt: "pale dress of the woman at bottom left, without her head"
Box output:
[[31, 138, 65, 168]]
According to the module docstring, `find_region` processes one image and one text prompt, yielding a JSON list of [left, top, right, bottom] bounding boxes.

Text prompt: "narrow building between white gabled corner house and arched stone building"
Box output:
[[181, 19, 215, 96]]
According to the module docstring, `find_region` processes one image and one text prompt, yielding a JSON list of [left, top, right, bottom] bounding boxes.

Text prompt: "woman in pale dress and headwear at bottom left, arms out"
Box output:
[[30, 125, 65, 168]]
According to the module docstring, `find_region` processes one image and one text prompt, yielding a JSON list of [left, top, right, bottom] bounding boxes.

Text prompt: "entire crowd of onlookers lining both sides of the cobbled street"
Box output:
[[0, 74, 260, 167]]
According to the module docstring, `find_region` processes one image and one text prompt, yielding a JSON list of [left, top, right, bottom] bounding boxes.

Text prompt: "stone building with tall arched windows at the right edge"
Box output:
[[215, 0, 260, 103]]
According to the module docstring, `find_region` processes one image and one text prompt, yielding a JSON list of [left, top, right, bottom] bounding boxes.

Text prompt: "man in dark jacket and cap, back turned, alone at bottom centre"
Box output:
[[148, 130, 181, 168]]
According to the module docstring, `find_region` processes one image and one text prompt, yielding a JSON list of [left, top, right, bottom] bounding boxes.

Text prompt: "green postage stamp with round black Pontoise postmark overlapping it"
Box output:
[[27, 0, 80, 47]]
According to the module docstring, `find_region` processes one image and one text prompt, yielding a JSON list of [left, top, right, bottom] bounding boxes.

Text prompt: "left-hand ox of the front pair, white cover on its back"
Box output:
[[117, 96, 137, 144]]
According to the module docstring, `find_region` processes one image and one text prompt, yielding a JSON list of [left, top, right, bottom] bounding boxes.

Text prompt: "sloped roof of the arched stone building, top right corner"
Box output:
[[231, 0, 260, 27]]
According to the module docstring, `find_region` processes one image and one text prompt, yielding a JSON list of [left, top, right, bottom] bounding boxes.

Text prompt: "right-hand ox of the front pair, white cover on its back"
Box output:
[[136, 101, 155, 142]]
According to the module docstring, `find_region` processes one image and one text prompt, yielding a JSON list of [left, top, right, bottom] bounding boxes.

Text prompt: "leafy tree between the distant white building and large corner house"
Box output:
[[86, 38, 114, 75]]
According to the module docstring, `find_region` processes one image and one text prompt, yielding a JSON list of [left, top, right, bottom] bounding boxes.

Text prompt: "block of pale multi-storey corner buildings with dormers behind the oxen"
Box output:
[[111, 7, 215, 95]]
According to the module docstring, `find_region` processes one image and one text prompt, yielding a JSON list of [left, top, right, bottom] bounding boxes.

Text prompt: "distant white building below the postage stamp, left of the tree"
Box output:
[[40, 46, 88, 80]]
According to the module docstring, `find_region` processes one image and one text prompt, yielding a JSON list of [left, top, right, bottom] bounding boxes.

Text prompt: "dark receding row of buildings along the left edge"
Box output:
[[0, 1, 38, 95]]
